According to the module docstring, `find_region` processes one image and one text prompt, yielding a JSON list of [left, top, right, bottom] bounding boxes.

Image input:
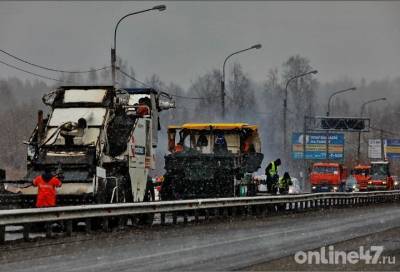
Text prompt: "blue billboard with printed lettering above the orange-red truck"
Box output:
[[292, 132, 344, 160]]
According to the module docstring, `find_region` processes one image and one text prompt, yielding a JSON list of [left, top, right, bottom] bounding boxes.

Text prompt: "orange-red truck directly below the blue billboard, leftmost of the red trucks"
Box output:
[[310, 162, 348, 193]]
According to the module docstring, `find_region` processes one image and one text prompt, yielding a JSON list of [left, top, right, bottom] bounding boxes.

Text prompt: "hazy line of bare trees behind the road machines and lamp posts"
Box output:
[[0, 55, 400, 178]]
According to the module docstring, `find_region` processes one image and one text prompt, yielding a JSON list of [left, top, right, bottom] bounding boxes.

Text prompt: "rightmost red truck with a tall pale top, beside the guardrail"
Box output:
[[368, 160, 394, 191]]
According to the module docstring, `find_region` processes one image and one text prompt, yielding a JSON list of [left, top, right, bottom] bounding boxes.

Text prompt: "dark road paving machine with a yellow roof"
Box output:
[[161, 123, 263, 200]]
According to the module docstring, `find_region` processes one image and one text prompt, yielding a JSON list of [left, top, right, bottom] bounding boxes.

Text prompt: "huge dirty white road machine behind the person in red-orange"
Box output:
[[0, 86, 174, 207]]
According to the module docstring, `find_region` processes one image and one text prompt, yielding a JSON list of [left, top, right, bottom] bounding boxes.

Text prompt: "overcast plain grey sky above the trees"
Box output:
[[0, 1, 400, 87]]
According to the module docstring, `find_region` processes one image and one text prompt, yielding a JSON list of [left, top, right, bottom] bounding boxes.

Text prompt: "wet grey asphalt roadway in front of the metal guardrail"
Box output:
[[0, 204, 400, 272]]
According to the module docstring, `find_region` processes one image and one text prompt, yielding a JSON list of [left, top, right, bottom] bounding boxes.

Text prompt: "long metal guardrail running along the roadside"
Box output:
[[0, 190, 400, 242]]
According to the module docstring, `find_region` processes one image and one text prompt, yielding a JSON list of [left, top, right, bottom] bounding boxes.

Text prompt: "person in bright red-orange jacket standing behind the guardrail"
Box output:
[[33, 168, 61, 208]]
